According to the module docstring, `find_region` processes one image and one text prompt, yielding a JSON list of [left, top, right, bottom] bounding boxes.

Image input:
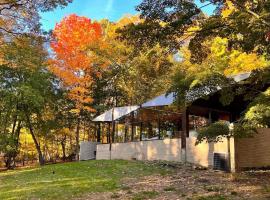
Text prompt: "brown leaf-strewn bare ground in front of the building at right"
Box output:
[[80, 162, 270, 200]]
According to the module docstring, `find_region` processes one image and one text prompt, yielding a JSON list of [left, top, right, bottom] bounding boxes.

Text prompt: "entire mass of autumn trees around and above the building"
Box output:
[[0, 0, 270, 168]]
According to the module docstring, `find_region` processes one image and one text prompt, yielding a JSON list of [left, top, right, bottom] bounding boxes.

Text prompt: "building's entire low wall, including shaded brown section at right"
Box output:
[[97, 129, 270, 171]]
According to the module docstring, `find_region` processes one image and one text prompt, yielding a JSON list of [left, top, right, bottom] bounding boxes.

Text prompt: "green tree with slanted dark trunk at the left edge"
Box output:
[[0, 36, 61, 165]]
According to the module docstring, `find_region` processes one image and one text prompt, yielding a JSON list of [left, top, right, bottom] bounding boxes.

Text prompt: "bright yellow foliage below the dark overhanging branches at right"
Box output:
[[180, 37, 270, 76]]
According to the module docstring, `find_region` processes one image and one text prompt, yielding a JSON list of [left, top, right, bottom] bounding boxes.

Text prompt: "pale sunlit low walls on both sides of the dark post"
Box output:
[[97, 137, 234, 167]]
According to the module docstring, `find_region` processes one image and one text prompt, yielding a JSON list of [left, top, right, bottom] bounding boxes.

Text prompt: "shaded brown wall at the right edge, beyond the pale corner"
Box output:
[[235, 129, 270, 170]]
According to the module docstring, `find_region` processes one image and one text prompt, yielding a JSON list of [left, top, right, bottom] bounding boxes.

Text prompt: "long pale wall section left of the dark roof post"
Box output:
[[97, 139, 181, 162]]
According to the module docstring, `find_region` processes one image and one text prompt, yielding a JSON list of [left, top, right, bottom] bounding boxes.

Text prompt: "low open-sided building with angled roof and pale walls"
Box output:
[[87, 73, 270, 171]]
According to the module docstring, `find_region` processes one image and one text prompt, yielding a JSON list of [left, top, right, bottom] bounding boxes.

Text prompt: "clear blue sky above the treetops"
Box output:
[[41, 0, 214, 31]]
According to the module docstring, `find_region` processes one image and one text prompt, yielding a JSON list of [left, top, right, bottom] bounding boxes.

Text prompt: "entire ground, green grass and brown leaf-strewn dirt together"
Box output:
[[0, 160, 270, 200]]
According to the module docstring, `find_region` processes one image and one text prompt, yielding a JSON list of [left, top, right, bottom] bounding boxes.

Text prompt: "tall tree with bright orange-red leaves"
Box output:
[[50, 14, 102, 112]]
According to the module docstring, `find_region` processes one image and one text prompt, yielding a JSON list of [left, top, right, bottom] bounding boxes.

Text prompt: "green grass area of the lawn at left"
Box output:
[[0, 160, 169, 200]]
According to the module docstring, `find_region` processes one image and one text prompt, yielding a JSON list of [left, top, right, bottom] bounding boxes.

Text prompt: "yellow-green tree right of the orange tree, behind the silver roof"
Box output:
[[89, 15, 172, 107]]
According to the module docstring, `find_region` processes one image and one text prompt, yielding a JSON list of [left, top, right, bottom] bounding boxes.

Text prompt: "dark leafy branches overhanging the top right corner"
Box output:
[[122, 0, 270, 62]]
